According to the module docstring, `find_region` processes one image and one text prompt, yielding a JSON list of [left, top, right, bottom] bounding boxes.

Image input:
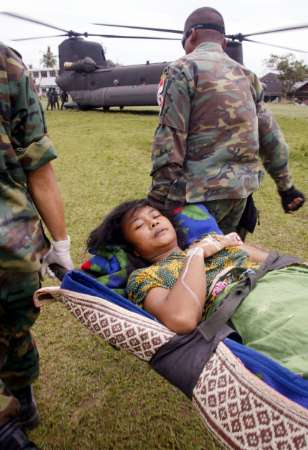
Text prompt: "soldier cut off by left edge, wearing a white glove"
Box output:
[[0, 43, 73, 450]]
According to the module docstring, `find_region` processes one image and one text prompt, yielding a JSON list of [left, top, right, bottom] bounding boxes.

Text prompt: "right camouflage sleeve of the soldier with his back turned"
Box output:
[[254, 77, 292, 191]]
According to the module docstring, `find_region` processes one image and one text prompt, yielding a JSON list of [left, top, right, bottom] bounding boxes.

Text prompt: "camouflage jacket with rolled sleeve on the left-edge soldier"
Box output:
[[0, 43, 56, 272]]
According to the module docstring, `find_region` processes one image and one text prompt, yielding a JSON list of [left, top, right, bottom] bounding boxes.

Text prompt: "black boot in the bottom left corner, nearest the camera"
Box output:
[[0, 419, 39, 450]]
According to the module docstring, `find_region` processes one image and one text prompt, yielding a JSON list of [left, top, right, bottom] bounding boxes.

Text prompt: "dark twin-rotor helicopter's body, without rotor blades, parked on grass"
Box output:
[[57, 37, 242, 109]]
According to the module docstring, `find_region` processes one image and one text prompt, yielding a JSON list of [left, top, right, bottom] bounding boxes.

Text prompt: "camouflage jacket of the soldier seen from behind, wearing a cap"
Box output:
[[149, 43, 292, 209]]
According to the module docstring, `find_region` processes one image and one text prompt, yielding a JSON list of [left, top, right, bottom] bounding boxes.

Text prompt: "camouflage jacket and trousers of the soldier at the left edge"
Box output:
[[0, 43, 56, 425]]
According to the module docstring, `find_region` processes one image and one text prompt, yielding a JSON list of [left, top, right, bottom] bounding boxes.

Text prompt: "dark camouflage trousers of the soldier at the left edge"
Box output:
[[0, 271, 40, 425]]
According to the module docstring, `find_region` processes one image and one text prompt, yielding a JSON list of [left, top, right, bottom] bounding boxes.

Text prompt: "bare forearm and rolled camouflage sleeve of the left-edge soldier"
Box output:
[[8, 48, 67, 241]]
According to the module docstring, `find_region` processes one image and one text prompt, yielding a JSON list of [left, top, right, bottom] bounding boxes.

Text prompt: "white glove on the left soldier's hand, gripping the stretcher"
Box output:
[[40, 236, 74, 278]]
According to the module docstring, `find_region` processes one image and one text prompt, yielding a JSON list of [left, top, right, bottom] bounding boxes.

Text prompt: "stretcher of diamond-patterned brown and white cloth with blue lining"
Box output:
[[34, 271, 308, 450]]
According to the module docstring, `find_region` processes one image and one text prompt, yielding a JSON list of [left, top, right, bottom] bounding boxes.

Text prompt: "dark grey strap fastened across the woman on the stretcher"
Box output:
[[150, 253, 300, 398]]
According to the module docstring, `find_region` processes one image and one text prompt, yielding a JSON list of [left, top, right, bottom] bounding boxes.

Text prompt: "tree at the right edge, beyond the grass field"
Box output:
[[265, 53, 308, 96]]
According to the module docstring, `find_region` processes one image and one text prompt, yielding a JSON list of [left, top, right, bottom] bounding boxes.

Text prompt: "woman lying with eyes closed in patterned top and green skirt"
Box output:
[[88, 200, 308, 378]]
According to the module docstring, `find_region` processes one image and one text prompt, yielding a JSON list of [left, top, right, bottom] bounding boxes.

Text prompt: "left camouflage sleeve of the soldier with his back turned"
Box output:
[[148, 62, 193, 209]]
